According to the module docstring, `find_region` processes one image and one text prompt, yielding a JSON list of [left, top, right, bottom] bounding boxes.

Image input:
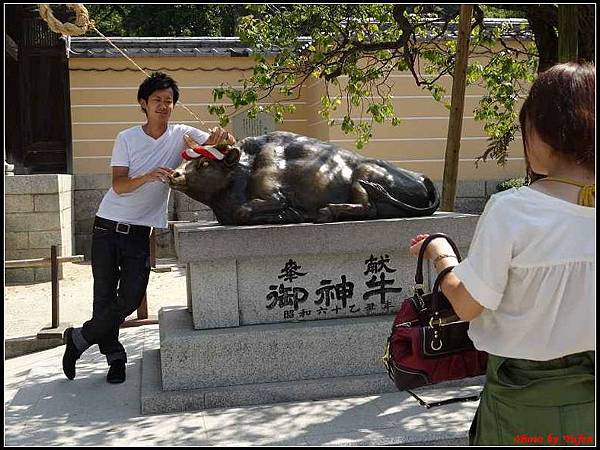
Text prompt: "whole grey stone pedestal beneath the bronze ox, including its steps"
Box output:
[[142, 213, 478, 413]]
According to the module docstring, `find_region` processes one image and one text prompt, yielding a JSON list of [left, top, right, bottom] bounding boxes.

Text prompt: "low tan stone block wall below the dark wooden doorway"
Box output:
[[4, 174, 74, 283]]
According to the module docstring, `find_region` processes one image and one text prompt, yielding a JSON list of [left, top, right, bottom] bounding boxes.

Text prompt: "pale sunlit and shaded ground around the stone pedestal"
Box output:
[[4, 264, 480, 446]]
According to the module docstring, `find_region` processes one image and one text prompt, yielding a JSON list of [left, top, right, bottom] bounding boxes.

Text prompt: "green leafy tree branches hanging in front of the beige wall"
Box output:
[[197, 4, 538, 163]]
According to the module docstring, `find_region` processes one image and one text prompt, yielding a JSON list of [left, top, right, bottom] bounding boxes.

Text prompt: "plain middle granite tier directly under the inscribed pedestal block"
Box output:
[[159, 307, 393, 390]]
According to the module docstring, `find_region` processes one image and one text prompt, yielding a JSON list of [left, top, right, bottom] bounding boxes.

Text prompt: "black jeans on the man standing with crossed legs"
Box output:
[[80, 217, 151, 364]]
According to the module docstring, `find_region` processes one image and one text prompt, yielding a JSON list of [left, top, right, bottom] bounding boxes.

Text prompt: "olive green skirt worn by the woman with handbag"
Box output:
[[469, 351, 596, 446]]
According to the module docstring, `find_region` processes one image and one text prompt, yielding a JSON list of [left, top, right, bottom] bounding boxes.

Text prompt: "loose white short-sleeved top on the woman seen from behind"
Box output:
[[453, 187, 596, 361]]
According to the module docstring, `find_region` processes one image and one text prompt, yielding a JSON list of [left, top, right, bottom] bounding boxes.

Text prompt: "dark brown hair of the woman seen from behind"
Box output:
[[519, 63, 596, 181]]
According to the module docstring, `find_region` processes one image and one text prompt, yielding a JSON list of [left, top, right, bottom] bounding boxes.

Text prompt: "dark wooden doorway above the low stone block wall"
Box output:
[[4, 5, 72, 174]]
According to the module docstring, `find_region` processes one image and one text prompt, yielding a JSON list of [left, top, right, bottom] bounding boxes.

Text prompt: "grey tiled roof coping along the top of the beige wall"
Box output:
[[67, 19, 531, 58]]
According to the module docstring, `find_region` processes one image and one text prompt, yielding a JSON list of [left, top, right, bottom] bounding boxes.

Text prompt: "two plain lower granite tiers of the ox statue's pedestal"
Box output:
[[141, 307, 483, 414]]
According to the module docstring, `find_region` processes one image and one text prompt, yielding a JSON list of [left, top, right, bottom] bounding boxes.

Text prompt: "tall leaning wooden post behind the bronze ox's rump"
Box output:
[[441, 5, 473, 211]]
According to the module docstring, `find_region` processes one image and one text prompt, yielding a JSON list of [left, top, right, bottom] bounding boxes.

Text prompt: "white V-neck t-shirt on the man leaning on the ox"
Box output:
[[97, 124, 209, 228]]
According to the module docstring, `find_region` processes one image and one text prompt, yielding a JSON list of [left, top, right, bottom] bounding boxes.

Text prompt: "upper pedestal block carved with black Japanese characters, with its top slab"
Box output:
[[174, 212, 479, 330]]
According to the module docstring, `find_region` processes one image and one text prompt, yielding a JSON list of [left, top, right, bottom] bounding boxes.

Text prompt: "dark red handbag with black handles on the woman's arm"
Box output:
[[383, 233, 487, 408]]
